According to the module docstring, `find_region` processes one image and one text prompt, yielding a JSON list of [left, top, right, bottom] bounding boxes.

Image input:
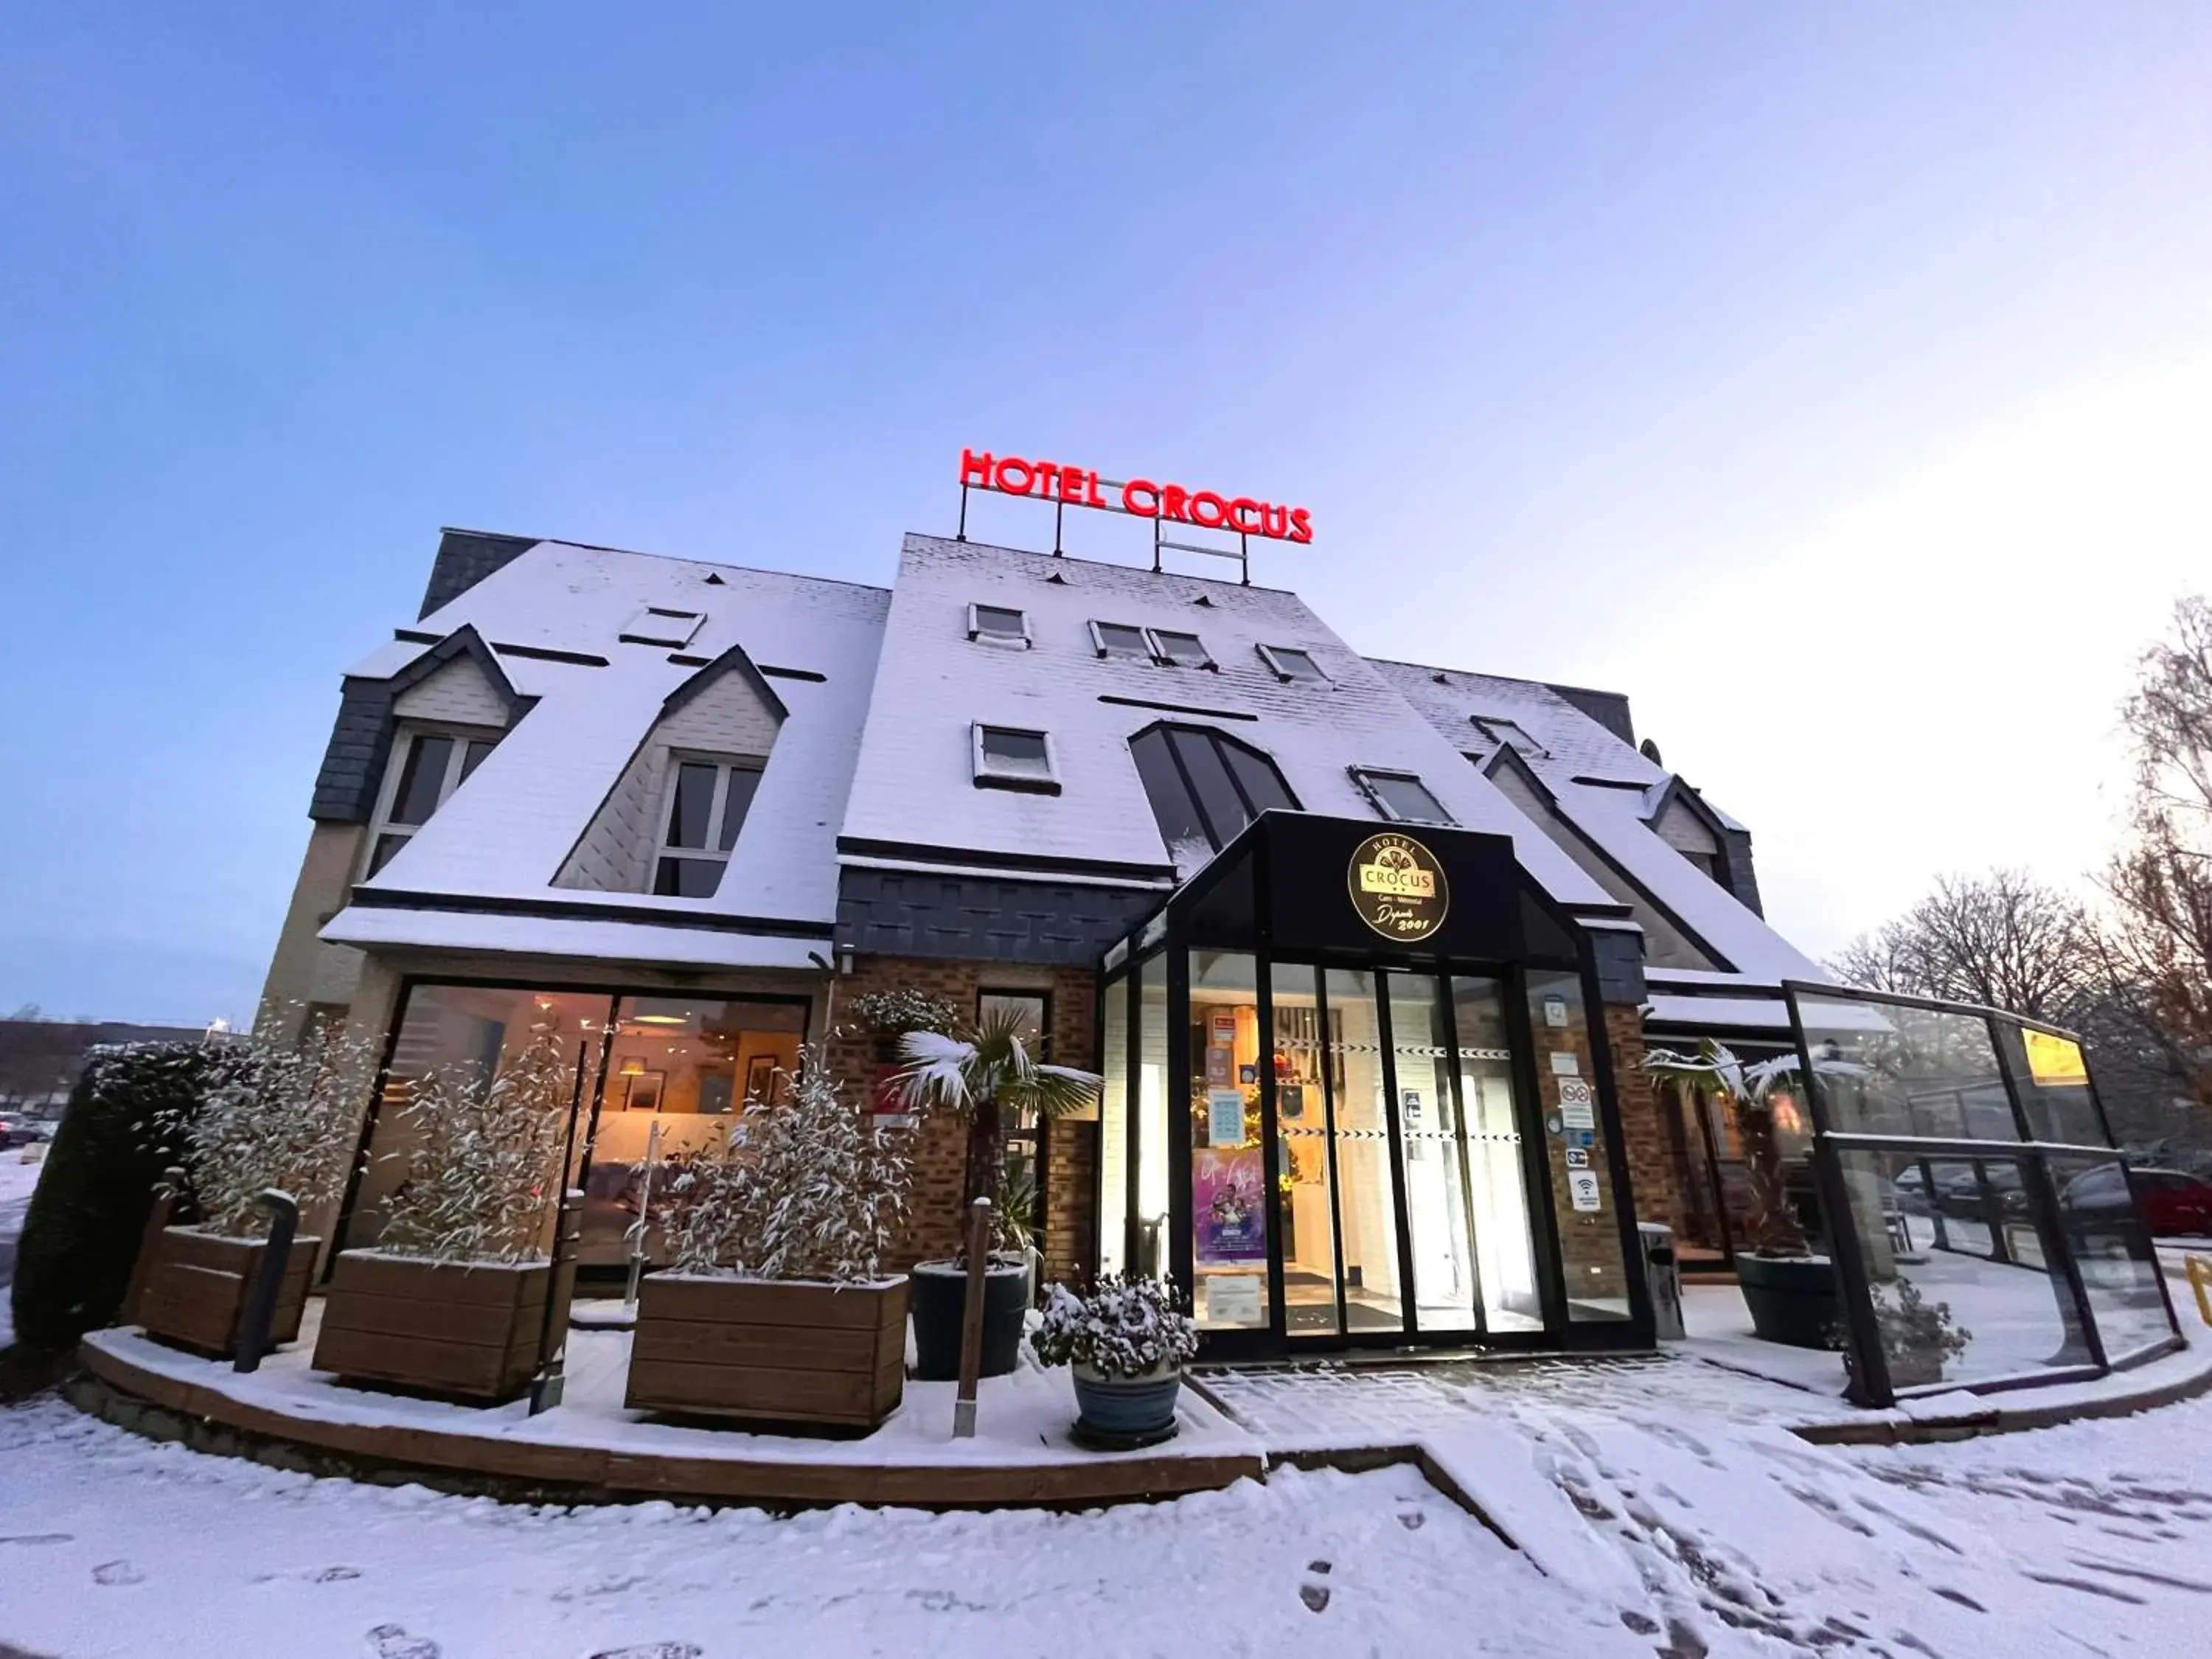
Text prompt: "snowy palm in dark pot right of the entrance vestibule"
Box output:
[[1644, 1037, 1843, 1347]]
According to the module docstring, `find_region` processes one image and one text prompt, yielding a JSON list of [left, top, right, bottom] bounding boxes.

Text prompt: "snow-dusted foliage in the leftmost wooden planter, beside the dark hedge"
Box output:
[[164, 1009, 376, 1237]]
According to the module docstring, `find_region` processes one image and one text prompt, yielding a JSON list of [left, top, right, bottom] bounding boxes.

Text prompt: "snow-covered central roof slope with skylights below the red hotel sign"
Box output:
[[845, 535, 1615, 909]]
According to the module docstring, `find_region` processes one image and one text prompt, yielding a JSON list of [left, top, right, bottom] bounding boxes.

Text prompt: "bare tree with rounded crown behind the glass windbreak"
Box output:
[[1827, 869, 2099, 1020]]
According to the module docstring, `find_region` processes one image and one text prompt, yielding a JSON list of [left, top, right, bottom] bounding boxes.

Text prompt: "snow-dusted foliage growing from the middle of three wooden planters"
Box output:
[[378, 1026, 575, 1261]]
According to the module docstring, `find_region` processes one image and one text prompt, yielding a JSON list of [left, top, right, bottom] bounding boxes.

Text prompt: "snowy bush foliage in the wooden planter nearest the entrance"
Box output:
[[661, 1057, 911, 1285]]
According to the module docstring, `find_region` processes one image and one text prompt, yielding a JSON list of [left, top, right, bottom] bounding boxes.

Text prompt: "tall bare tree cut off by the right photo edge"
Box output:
[[2099, 597, 2212, 1106]]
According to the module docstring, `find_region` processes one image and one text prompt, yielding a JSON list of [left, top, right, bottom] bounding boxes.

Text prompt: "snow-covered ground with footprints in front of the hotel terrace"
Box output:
[[0, 1159, 2212, 1659]]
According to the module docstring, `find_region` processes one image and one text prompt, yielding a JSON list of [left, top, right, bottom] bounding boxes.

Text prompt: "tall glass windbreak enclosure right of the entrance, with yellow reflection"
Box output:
[[1785, 984, 2181, 1405]]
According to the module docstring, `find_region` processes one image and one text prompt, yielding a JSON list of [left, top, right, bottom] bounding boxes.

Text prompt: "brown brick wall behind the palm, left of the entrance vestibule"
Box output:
[[830, 956, 1097, 1279]]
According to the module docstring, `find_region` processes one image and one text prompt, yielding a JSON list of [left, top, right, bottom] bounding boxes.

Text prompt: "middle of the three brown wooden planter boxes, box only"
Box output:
[[314, 1250, 566, 1402]]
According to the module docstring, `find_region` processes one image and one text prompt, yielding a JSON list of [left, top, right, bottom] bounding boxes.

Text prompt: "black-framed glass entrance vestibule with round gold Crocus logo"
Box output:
[[1099, 812, 1650, 1358]]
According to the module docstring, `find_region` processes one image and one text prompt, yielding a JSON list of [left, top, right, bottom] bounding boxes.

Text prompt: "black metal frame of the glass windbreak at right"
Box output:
[[1781, 980, 2183, 1407]]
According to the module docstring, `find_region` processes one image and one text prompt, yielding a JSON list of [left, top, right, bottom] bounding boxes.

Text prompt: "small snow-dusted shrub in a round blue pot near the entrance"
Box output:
[[1029, 1274, 1199, 1451]]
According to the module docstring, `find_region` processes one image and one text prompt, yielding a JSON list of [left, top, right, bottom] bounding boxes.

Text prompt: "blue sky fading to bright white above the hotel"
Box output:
[[0, 2, 2212, 1020]]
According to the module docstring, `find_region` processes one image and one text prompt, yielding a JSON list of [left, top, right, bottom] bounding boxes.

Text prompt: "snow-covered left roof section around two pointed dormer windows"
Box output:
[[325, 542, 889, 964]]
